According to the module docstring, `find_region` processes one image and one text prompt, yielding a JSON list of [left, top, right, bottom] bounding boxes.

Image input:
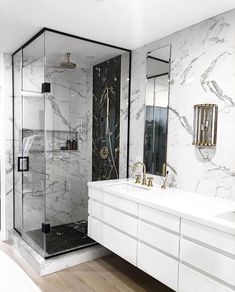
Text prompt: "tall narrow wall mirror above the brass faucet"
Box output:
[[144, 45, 171, 176]]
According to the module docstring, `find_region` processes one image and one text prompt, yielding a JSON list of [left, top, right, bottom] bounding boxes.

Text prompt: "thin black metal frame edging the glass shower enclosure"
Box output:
[[12, 27, 132, 259]]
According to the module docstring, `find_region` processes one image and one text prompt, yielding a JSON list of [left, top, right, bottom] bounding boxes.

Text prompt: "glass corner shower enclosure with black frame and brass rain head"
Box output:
[[12, 28, 131, 258]]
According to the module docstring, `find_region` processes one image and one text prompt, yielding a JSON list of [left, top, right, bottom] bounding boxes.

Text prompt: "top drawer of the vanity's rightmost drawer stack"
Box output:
[[181, 219, 235, 255]]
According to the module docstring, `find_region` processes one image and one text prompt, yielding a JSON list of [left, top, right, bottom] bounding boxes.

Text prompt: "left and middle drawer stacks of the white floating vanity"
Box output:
[[88, 188, 180, 291]]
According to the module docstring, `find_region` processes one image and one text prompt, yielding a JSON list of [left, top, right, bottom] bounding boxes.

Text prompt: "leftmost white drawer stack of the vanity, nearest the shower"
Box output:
[[88, 188, 138, 266]]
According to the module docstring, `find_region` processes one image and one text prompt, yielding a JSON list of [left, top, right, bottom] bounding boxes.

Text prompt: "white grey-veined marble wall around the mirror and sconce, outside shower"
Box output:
[[130, 10, 235, 200]]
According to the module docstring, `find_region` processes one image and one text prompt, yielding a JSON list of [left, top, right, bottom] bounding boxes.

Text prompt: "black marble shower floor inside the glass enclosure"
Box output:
[[27, 220, 96, 256]]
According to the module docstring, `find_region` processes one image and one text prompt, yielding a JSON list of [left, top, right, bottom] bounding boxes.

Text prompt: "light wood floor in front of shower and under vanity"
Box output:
[[0, 243, 172, 292]]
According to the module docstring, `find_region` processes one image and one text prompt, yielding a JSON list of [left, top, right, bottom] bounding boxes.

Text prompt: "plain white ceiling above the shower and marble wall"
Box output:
[[0, 0, 235, 52]]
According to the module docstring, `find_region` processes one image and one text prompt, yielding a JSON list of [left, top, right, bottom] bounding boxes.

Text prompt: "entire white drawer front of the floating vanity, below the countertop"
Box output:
[[88, 187, 235, 292]]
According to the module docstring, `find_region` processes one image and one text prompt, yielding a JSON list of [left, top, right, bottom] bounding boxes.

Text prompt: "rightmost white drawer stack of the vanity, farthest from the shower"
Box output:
[[179, 219, 235, 292]]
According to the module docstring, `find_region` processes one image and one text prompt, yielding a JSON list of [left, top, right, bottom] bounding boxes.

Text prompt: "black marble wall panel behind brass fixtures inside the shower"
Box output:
[[92, 56, 121, 180]]
